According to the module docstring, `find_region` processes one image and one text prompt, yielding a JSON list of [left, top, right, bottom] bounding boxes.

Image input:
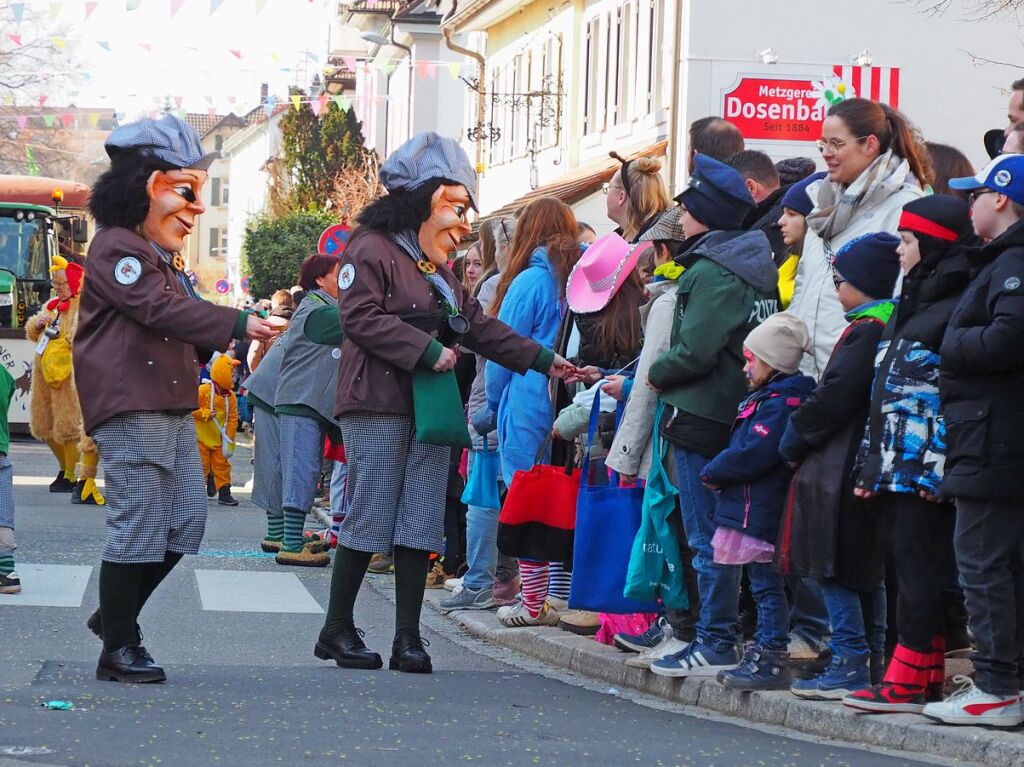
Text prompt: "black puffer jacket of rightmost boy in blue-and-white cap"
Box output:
[[939, 221, 1024, 501]]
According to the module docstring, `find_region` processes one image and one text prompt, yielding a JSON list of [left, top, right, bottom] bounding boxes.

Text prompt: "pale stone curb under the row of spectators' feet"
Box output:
[[426, 590, 1024, 767]]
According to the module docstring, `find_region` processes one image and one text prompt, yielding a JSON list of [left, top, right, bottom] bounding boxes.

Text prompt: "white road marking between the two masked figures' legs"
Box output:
[[195, 569, 324, 614]]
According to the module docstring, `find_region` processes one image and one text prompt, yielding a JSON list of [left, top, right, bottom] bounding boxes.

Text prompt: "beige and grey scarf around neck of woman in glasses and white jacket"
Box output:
[[807, 150, 918, 240]]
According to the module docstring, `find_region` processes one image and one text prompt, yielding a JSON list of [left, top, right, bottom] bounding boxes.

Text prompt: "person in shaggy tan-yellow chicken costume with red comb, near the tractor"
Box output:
[[26, 256, 104, 506]]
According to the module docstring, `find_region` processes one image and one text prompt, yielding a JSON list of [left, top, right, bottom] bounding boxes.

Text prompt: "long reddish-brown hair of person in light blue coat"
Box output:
[[490, 197, 580, 316]]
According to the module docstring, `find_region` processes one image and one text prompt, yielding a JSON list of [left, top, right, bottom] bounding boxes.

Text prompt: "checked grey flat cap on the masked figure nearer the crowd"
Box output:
[[380, 133, 478, 210]]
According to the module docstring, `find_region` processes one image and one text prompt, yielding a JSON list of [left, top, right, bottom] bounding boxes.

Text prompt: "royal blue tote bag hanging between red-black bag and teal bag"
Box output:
[[569, 394, 657, 614]]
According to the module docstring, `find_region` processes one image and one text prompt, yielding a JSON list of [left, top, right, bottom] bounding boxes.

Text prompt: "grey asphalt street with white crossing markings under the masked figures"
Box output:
[[0, 441, 954, 767]]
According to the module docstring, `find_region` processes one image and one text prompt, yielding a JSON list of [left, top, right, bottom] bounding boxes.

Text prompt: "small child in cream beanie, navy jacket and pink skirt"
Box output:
[[700, 312, 814, 690]]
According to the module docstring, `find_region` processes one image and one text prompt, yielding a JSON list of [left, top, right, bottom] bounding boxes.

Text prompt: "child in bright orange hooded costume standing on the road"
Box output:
[[193, 354, 241, 506]]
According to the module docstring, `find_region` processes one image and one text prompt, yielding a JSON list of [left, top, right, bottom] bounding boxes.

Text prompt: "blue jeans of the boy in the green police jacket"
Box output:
[[672, 448, 740, 652]]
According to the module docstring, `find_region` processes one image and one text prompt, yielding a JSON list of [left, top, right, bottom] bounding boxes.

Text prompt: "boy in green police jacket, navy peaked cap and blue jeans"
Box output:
[[647, 155, 778, 678]]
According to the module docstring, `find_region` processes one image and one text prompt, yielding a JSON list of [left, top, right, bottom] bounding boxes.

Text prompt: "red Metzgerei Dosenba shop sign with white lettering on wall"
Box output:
[[722, 77, 826, 141]]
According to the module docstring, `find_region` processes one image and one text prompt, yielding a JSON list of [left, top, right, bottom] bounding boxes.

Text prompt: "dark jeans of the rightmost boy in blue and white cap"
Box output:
[[953, 498, 1024, 695]]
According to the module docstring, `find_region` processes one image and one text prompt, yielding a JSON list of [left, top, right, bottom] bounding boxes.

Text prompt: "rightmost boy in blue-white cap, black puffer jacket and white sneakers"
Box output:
[[923, 155, 1024, 727]]
